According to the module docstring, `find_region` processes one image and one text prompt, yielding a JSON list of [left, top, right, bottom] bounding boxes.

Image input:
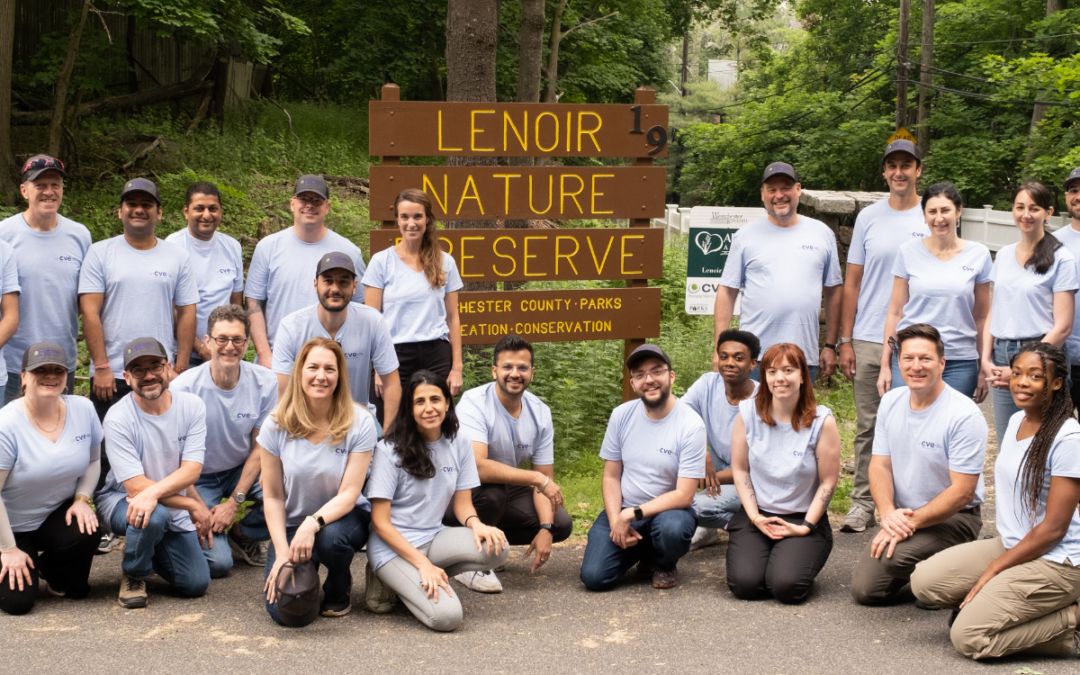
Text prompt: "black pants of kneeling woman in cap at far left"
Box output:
[[0, 497, 102, 615]]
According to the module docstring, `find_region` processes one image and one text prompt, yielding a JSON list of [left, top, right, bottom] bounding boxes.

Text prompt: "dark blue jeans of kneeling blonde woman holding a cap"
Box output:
[[262, 508, 372, 624]]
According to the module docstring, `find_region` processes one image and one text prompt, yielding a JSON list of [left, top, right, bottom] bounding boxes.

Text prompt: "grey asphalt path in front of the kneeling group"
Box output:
[[0, 399, 1080, 675]]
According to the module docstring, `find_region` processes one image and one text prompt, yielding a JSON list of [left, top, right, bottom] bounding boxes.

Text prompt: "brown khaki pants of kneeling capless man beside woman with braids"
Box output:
[[851, 513, 983, 605]]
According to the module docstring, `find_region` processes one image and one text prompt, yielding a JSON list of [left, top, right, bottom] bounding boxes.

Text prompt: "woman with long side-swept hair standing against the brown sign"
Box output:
[[364, 188, 463, 423]]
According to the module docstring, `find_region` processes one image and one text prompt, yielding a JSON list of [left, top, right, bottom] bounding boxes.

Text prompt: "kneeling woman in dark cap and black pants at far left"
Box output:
[[0, 342, 102, 615]]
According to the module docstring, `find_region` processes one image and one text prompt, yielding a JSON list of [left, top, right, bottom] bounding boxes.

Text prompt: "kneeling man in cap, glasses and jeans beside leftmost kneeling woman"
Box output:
[[94, 337, 216, 609]]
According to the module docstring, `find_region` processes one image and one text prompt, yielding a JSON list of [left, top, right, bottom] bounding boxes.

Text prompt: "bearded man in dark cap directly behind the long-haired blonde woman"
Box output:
[[271, 251, 402, 427]]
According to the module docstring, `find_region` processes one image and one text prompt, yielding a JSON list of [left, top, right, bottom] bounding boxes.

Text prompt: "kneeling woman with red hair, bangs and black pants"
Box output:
[[728, 342, 840, 605]]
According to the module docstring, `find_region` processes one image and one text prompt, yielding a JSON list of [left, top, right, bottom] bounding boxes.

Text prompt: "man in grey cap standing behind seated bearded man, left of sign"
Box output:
[[244, 174, 367, 368]]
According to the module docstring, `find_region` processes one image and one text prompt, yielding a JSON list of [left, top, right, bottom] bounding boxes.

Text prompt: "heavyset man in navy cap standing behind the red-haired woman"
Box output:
[[713, 162, 842, 380]]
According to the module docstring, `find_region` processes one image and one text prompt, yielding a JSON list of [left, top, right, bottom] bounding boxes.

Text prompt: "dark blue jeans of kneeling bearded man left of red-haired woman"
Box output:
[[581, 509, 698, 591]]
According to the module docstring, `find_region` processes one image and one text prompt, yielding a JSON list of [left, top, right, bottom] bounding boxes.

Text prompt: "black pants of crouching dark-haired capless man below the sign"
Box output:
[[443, 483, 573, 546]]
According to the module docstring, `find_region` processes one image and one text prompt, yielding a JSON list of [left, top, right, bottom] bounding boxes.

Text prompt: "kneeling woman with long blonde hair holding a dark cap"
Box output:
[[262, 338, 376, 626]]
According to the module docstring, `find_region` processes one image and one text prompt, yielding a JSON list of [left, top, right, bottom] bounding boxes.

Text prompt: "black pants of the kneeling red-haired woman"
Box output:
[[728, 509, 833, 605]]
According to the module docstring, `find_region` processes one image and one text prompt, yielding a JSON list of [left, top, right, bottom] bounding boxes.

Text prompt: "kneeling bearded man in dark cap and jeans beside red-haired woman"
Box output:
[[581, 345, 706, 591]]
